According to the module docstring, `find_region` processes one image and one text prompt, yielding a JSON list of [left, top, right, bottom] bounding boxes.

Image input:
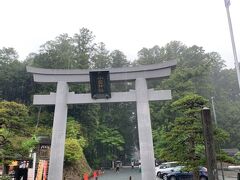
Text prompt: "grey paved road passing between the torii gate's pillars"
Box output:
[[98, 167, 160, 180]]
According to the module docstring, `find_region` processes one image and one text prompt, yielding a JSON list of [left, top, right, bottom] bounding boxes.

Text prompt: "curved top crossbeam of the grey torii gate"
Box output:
[[27, 60, 177, 82]]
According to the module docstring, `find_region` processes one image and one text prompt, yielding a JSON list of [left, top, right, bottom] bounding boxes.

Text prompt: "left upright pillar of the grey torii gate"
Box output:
[[48, 81, 68, 180]]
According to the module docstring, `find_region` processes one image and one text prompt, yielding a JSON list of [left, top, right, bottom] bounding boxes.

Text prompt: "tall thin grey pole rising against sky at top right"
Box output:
[[224, 0, 240, 89]]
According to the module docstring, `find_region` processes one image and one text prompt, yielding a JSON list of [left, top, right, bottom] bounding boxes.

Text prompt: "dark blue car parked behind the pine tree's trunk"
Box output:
[[167, 167, 208, 180]]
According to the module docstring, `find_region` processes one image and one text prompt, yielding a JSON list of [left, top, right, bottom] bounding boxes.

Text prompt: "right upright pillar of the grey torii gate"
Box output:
[[135, 78, 156, 180]]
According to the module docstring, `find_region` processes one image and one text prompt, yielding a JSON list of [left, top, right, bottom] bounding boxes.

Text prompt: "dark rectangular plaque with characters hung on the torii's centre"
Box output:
[[89, 71, 111, 99]]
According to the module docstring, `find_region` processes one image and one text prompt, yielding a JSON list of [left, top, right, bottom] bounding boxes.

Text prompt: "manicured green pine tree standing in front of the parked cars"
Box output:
[[162, 94, 207, 180]]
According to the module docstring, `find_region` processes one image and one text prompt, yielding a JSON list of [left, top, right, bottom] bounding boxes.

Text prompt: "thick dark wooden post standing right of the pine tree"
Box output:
[[202, 107, 218, 180]]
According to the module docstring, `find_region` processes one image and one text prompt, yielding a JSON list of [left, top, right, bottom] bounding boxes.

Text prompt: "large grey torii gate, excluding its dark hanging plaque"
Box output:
[[27, 60, 176, 180]]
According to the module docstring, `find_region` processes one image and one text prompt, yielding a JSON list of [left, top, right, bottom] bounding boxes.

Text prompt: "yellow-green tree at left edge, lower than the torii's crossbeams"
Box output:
[[0, 101, 38, 174]]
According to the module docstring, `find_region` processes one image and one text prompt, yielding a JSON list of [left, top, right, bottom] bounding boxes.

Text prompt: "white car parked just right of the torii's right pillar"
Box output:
[[155, 161, 183, 180]]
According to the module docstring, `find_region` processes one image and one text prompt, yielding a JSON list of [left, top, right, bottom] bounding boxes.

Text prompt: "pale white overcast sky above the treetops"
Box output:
[[0, 0, 240, 68]]
